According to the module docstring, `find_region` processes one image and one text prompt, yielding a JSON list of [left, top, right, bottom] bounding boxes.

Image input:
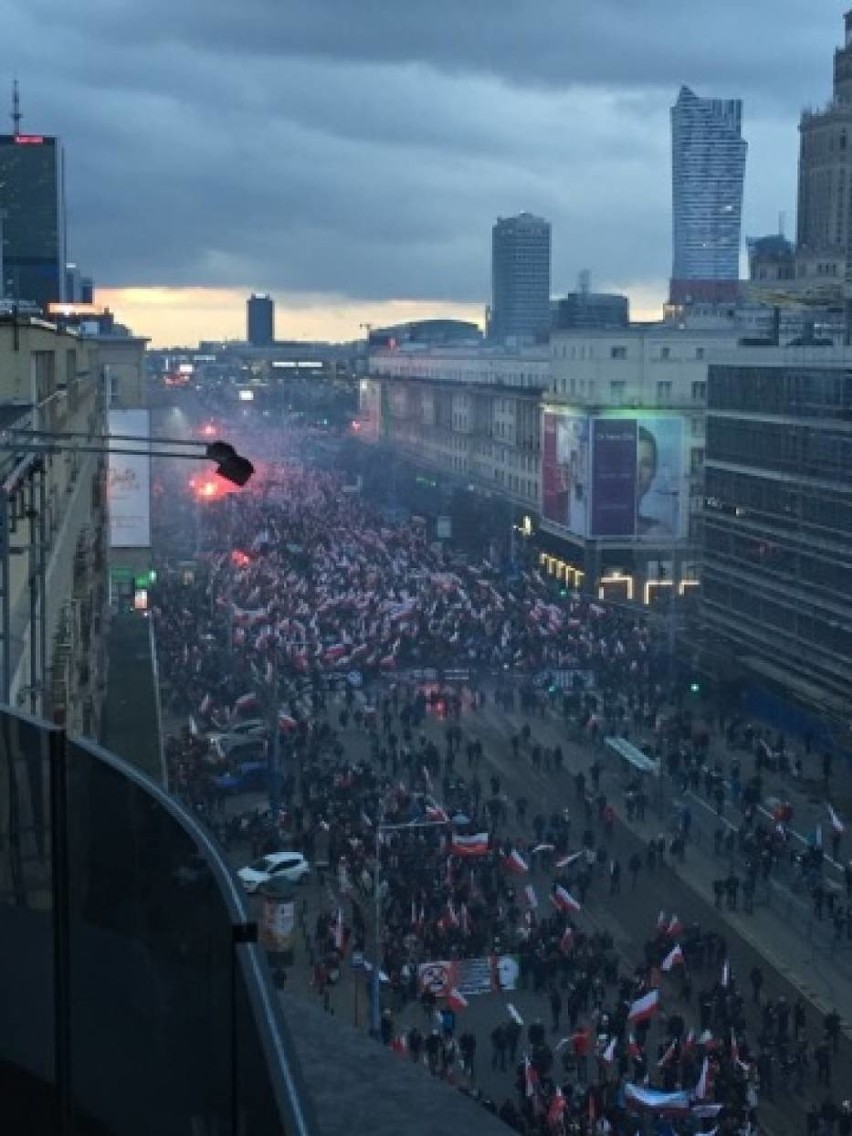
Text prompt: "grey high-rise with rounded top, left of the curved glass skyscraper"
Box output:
[[488, 212, 550, 343]]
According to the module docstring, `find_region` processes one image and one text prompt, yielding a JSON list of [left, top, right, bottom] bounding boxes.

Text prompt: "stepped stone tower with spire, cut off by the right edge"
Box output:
[[796, 11, 852, 291]]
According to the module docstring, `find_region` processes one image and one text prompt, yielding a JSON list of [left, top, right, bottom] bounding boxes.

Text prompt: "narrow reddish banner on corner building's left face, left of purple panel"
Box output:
[[542, 410, 590, 536]]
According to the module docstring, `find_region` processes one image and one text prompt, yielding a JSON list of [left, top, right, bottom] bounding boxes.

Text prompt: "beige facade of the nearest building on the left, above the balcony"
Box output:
[[0, 319, 107, 735]]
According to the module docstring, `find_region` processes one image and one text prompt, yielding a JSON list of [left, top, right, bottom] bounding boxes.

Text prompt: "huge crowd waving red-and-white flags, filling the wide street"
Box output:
[[153, 449, 852, 1136]]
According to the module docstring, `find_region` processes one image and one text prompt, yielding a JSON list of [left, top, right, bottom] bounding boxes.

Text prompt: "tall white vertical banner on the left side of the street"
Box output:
[[108, 410, 151, 549]]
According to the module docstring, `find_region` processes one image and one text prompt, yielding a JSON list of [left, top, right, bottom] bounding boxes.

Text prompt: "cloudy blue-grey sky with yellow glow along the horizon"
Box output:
[[0, 0, 847, 340]]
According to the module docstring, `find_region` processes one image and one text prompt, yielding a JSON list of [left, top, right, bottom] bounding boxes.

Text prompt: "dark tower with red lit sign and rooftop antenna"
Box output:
[[0, 83, 65, 308]]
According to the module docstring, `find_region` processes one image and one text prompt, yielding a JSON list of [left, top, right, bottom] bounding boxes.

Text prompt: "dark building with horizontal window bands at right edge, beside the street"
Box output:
[[702, 352, 852, 716]]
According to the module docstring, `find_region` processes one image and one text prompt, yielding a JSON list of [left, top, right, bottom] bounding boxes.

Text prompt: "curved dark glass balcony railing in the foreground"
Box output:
[[0, 709, 316, 1136]]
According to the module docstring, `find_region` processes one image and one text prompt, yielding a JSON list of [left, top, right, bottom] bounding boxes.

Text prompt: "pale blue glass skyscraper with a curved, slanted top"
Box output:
[[669, 86, 747, 303]]
